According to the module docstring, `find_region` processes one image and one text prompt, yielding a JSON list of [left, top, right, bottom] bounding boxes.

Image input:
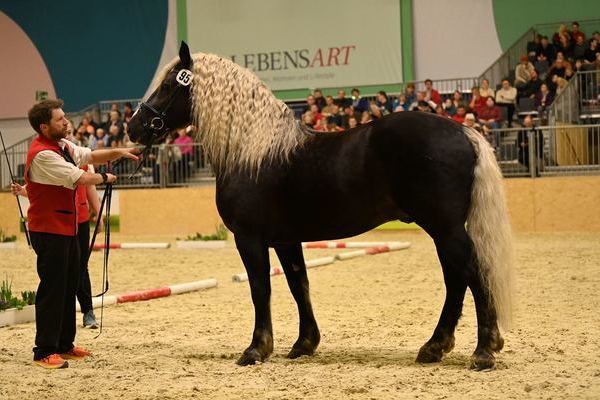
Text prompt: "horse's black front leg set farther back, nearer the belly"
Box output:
[[275, 243, 321, 358]]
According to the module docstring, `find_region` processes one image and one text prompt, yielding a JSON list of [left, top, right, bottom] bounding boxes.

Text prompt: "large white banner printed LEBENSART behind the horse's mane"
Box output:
[[187, 0, 402, 90]]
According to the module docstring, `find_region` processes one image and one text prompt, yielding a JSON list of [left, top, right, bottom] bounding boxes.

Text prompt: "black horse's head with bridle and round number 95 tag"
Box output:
[[127, 42, 194, 145]]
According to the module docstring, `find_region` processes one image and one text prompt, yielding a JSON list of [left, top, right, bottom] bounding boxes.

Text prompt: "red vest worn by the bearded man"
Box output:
[[25, 135, 77, 236]]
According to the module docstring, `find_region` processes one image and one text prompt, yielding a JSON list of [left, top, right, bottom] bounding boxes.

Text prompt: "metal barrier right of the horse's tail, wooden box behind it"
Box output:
[[492, 124, 600, 177]]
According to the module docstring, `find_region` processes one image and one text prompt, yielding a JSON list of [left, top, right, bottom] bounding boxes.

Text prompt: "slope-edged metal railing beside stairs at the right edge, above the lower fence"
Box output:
[[548, 70, 600, 125]]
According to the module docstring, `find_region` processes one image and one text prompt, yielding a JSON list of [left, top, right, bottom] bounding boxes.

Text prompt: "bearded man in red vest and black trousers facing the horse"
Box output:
[[25, 100, 138, 368]]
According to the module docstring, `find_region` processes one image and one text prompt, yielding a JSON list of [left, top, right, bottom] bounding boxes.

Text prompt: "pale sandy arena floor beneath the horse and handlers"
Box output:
[[0, 232, 600, 400]]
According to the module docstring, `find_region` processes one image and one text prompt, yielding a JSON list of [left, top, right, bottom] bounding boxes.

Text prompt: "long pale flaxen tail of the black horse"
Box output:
[[464, 128, 514, 329]]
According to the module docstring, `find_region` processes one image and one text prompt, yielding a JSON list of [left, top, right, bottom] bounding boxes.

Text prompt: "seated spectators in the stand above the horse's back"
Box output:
[[302, 22, 600, 141]]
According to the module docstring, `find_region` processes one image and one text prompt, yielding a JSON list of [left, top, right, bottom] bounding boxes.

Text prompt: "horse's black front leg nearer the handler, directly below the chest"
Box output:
[[235, 234, 273, 365]]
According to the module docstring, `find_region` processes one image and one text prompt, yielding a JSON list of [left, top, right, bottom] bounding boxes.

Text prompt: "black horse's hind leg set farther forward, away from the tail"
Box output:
[[417, 227, 472, 363]]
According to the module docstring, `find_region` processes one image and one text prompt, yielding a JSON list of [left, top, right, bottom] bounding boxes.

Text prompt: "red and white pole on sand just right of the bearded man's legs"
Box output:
[[77, 279, 217, 311]]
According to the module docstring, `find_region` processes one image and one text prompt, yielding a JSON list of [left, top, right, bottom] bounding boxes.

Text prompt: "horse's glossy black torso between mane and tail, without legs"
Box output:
[[217, 113, 474, 241]]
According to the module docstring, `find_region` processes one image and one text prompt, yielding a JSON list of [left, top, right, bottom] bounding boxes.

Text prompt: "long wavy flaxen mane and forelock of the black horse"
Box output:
[[161, 53, 307, 176]]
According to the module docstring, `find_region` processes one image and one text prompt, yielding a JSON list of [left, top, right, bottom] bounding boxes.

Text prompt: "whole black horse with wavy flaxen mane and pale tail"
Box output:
[[128, 43, 512, 369]]
